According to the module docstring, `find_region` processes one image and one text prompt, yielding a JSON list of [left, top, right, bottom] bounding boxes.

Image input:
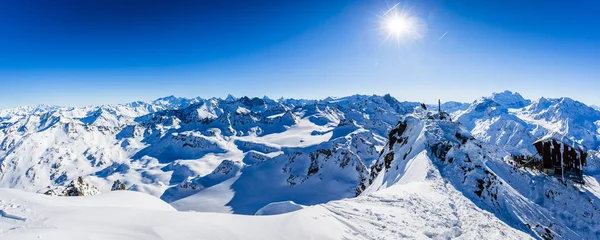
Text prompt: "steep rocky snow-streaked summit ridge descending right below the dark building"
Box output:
[[363, 116, 600, 239]]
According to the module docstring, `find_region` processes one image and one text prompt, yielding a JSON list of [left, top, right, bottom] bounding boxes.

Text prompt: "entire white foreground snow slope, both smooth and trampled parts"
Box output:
[[0, 188, 527, 240]]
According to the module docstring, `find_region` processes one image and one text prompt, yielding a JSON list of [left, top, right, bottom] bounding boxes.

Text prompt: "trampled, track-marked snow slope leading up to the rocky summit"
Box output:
[[325, 166, 531, 239]]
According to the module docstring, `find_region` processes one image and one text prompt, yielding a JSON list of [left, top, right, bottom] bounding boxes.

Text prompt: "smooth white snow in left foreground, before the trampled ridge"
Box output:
[[0, 189, 351, 240]]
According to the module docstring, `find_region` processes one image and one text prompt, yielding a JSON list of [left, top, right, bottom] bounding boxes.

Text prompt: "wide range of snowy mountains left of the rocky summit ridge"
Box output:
[[0, 95, 418, 214]]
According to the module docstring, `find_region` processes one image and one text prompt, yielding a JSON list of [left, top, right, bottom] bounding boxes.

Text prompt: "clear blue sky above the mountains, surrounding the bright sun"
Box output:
[[0, 0, 600, 108]]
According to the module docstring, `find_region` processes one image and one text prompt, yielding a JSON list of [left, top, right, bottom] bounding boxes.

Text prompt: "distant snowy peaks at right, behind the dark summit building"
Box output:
[[454, 91, 600, 155]]
